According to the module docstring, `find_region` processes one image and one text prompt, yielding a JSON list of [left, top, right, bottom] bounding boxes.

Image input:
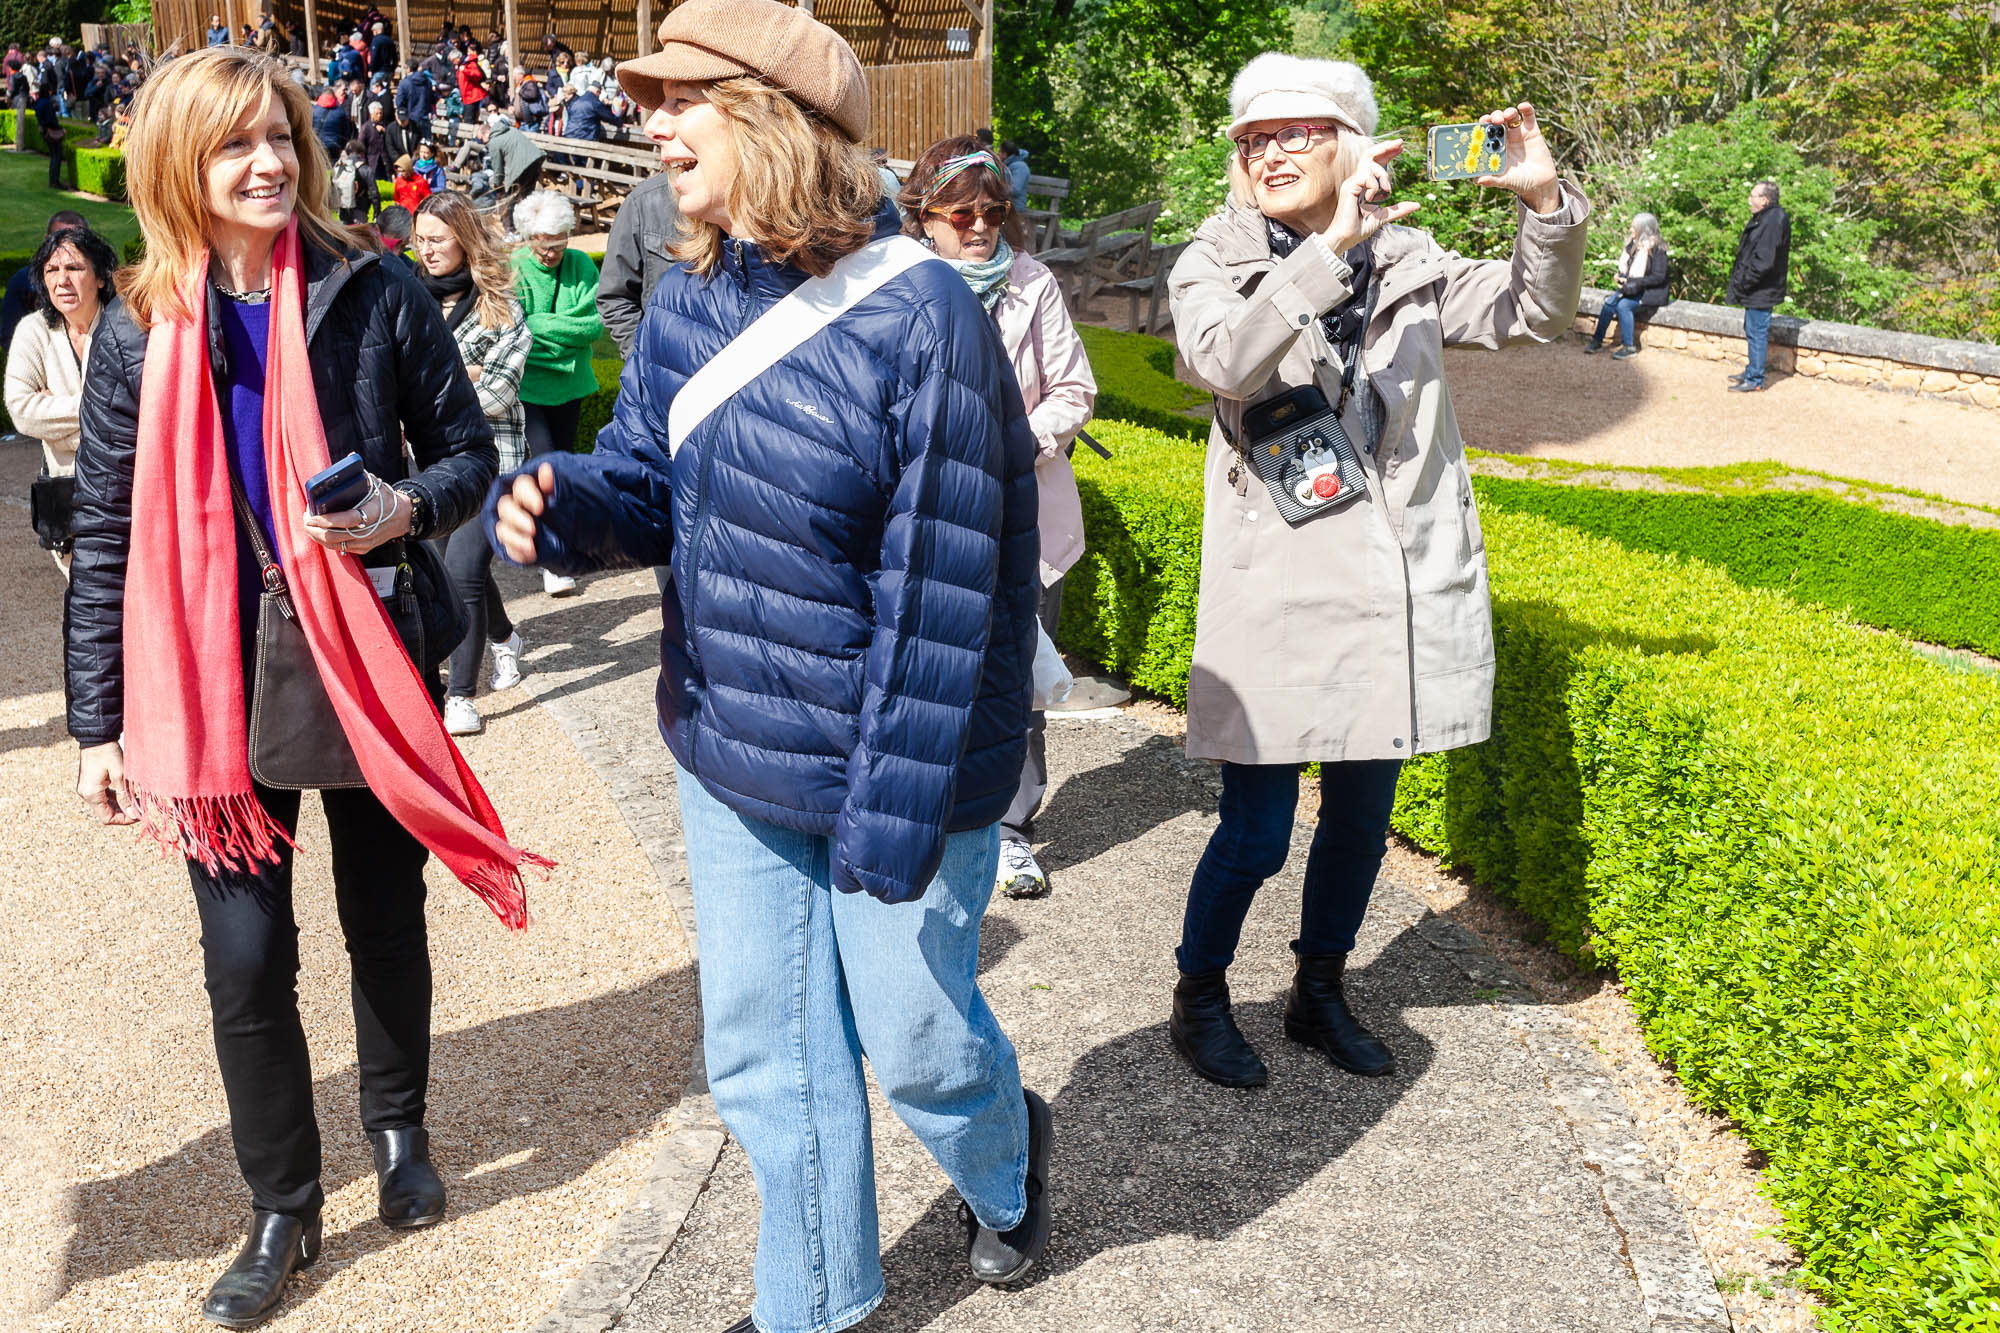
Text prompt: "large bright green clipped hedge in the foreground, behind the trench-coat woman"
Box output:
[[1060, 426, 2000, 1331]]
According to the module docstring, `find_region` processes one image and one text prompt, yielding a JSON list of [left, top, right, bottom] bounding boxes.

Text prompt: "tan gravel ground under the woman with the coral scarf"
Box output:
[[0, 442, 694, 1333]]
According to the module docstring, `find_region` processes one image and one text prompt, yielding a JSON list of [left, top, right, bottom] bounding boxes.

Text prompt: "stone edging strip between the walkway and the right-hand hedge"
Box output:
[[1096, 715, 1734, 1333]]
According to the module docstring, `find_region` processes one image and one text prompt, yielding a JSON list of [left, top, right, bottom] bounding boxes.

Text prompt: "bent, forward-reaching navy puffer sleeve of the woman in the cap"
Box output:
[[482, 330, 674, 574]]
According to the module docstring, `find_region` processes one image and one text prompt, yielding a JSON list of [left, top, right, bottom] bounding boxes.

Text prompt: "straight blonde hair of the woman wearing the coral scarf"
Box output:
[[118, 46, 352, 328]]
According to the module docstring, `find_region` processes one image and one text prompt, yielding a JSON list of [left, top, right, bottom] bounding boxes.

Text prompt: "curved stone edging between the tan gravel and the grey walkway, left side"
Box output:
[[522, 675, 728, 1333]]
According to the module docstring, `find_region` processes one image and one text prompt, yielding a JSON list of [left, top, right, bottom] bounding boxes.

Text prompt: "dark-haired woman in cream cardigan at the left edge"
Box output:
[[6, 226, 118, 576]]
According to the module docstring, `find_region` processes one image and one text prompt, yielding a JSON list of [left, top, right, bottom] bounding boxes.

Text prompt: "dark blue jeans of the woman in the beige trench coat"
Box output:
[[1174, 759, 1402, 975]]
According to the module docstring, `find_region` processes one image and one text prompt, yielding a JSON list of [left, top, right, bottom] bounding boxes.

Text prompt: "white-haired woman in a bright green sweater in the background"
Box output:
[[514, 190, 604, 596]]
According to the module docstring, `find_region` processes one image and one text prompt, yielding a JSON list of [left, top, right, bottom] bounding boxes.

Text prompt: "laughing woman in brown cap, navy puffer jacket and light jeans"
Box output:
[[486, 0, 1054, 1333]]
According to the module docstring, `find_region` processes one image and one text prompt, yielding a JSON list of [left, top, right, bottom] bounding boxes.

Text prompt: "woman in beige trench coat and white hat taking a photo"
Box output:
[[1170, 54, 1590, 1087]]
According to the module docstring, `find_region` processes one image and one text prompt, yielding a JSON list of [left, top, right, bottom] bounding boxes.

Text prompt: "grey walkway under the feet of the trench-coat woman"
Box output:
[[618, 704, 1728, 1333]]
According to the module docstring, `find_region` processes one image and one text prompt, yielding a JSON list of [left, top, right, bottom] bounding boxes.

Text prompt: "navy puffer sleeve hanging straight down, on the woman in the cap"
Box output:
[[832, 288, 1030, 903]]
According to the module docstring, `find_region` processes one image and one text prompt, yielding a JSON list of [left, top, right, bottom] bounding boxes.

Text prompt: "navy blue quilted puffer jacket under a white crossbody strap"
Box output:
[[486, 208, 1040, 903]]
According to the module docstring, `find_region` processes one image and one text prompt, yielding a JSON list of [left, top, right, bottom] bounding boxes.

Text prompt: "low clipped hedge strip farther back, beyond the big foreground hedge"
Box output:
[[1474, 476, 2000, 654]]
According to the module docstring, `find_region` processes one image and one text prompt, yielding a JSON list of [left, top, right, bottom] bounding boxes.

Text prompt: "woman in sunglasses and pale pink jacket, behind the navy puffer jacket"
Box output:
[[896, 134, 1098, 899]]
